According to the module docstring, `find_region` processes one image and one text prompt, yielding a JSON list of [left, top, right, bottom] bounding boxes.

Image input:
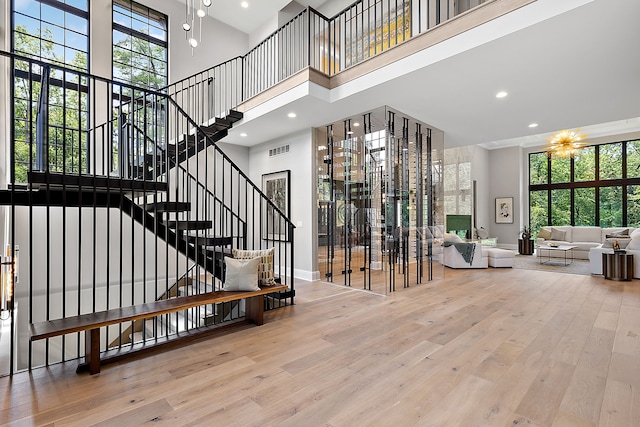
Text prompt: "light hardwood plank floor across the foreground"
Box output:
[[0, 269, 640, 427]]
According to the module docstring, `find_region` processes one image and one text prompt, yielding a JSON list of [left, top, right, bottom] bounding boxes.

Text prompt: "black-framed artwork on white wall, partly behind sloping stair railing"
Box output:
[[262, 170, 291, 241]]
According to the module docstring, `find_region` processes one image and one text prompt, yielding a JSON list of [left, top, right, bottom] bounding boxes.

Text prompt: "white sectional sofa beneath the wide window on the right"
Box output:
[[536, 225, 635, 260]]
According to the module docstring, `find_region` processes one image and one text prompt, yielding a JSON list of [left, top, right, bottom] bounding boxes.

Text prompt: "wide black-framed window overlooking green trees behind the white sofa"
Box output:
[[529, 140, 640, 232]]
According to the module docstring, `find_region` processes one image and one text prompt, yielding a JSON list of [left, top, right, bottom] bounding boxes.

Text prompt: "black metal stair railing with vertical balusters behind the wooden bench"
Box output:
[[0, 52, 294, 370]]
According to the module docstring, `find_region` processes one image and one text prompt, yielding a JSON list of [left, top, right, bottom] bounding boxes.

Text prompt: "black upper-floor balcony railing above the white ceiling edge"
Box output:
[[167, 0, 488, 123]]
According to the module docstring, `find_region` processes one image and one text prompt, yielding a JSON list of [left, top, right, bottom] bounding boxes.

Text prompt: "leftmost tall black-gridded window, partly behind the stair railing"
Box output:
[[12, 0, 89, 182]]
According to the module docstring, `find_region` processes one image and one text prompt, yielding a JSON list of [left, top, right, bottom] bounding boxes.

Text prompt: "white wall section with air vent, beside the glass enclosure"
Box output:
[[249, 129, 320, 280]]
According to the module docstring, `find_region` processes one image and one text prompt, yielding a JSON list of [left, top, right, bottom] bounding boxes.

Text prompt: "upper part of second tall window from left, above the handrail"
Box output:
[[113, 0, 168, 90]]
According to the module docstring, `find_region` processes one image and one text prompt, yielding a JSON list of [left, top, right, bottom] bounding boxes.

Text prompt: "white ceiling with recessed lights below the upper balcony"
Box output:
[[195, 0, 640, 148]]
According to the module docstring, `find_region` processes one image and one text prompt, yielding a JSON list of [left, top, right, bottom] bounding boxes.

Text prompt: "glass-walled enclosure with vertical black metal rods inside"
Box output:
[[315, 107, 444, 294]]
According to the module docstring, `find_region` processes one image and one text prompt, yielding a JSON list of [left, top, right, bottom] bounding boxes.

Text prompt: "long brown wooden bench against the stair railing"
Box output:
[[30, 285, 288, 375]]
